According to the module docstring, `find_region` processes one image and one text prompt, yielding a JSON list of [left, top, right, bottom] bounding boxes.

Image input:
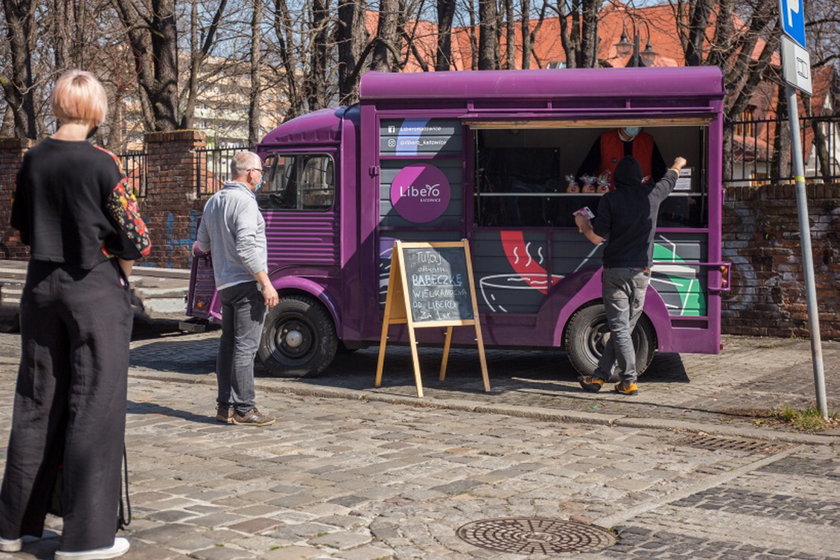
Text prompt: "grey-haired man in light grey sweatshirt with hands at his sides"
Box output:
[[195, 152, 278, 426]]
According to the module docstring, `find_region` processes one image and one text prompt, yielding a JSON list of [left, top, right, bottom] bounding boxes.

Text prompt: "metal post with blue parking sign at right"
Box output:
[[779, 0, 828, 420]]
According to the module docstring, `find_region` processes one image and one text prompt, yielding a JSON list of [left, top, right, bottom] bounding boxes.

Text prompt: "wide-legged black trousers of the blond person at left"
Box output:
[[0, 261, 132, 552]]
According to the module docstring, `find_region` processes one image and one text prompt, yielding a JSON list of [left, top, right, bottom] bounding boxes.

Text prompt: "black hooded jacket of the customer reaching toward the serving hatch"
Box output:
[[592, 156, 677, 268]]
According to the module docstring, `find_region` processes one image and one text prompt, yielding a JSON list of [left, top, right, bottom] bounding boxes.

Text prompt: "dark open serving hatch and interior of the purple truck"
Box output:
[[468, 121, 708, 228]]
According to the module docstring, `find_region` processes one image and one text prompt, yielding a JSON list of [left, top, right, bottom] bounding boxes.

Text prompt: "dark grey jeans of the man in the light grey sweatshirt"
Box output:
[[216, 282, 265, 414]]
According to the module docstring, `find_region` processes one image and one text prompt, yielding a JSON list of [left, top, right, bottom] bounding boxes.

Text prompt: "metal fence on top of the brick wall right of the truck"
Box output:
[[723, 116, 840, 186]]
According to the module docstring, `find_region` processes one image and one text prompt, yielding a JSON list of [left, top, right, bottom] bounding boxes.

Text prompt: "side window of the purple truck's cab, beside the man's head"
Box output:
[[257, 154, 335, 210]]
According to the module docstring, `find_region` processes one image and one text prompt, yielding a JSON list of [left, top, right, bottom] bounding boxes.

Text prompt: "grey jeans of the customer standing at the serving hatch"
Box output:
[[594, 268, 650, 383]]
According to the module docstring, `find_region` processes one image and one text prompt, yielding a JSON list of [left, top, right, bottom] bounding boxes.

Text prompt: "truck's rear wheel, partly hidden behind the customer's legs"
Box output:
[[565, 303, 656, 375]]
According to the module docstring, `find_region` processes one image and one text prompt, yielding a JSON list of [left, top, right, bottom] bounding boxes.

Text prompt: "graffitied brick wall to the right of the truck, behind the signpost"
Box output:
[[723, 185, 840, 339]]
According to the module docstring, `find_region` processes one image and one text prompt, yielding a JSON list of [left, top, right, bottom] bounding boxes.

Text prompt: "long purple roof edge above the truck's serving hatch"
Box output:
[[359, 66, 724, 102]]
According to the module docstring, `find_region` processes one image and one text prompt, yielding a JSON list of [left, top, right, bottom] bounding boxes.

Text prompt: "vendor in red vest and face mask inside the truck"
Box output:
[[577, 126, 666, 190]]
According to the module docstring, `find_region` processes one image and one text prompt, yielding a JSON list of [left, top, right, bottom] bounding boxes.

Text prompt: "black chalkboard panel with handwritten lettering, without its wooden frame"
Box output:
[[402, 246, 475, 323]]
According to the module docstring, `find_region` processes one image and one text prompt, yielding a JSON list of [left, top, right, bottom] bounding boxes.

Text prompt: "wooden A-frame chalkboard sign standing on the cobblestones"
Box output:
[[374, 239, 490, 397]]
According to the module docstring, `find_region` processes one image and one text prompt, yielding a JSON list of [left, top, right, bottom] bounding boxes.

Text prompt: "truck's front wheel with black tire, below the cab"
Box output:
[[258, 294, 338, 377]]
